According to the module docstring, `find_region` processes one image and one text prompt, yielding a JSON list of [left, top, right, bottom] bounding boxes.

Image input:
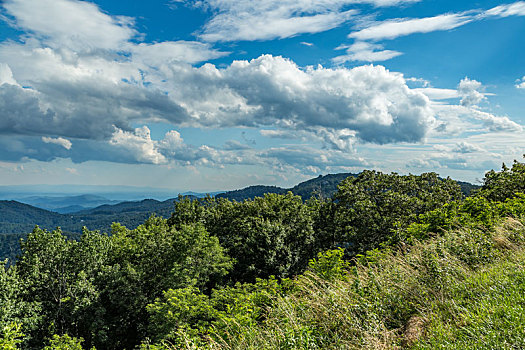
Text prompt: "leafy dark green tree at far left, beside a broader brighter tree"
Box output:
[[16, 227, 104, 347]]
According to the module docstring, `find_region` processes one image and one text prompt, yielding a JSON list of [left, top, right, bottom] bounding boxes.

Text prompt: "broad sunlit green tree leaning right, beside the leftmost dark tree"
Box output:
[[97, 217, 231, 349]]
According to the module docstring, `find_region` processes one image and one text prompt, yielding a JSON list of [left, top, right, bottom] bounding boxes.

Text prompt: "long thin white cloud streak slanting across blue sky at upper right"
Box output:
[[348, 14, 472, 40]]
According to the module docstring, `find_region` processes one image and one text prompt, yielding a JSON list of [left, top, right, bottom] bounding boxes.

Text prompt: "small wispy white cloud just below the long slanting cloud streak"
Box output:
[[332, 41, 403, 64]]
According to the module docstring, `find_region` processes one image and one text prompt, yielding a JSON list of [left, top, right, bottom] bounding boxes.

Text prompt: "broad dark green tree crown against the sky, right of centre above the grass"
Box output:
[[331, 171, 462, 255]]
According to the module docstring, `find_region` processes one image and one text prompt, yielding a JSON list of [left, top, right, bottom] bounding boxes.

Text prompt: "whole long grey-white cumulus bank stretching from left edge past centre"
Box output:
[[0, 40, 432, 148]]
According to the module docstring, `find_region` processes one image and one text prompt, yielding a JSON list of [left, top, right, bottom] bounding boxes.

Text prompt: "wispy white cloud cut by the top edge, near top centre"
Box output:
[[190, 0, 419, 42]]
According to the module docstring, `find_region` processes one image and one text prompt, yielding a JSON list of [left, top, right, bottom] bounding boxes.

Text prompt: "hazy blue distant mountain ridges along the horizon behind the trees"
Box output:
[[0, 173, 479, 260]]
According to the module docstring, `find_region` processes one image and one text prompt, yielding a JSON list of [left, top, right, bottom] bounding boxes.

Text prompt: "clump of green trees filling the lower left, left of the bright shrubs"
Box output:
[[6, 217, 232, 349]]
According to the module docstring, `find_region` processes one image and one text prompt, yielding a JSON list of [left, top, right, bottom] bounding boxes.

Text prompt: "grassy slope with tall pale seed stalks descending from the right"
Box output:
[[168, 219, 525, 349]]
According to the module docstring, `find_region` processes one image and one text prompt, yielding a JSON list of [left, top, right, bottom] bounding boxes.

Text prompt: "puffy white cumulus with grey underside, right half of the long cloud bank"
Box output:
[[182, 55, 433, 143]]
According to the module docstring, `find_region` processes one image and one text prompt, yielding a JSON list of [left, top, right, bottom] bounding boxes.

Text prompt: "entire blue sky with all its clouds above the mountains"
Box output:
[[0, 0, 525, 191]]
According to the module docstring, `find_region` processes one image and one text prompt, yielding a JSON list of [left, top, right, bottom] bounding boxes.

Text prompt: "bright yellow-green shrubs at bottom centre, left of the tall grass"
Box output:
[[143, 278, 290, 349]]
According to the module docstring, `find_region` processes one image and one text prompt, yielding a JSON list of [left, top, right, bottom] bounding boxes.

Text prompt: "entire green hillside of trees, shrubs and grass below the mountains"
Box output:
[[0, 157, 525, 350]]
